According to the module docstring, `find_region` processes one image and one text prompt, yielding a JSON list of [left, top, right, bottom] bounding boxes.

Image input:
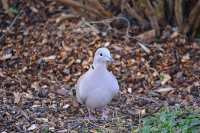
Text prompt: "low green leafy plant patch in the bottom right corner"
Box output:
[[139, 106, 200, 133]]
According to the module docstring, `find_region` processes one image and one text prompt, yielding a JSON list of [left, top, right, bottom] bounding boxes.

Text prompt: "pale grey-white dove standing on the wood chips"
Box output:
[[75, 48, 119, 119]]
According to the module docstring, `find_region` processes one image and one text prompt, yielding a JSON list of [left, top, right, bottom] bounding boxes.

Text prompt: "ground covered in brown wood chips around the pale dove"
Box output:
[[0, 2, 200, 132]]
